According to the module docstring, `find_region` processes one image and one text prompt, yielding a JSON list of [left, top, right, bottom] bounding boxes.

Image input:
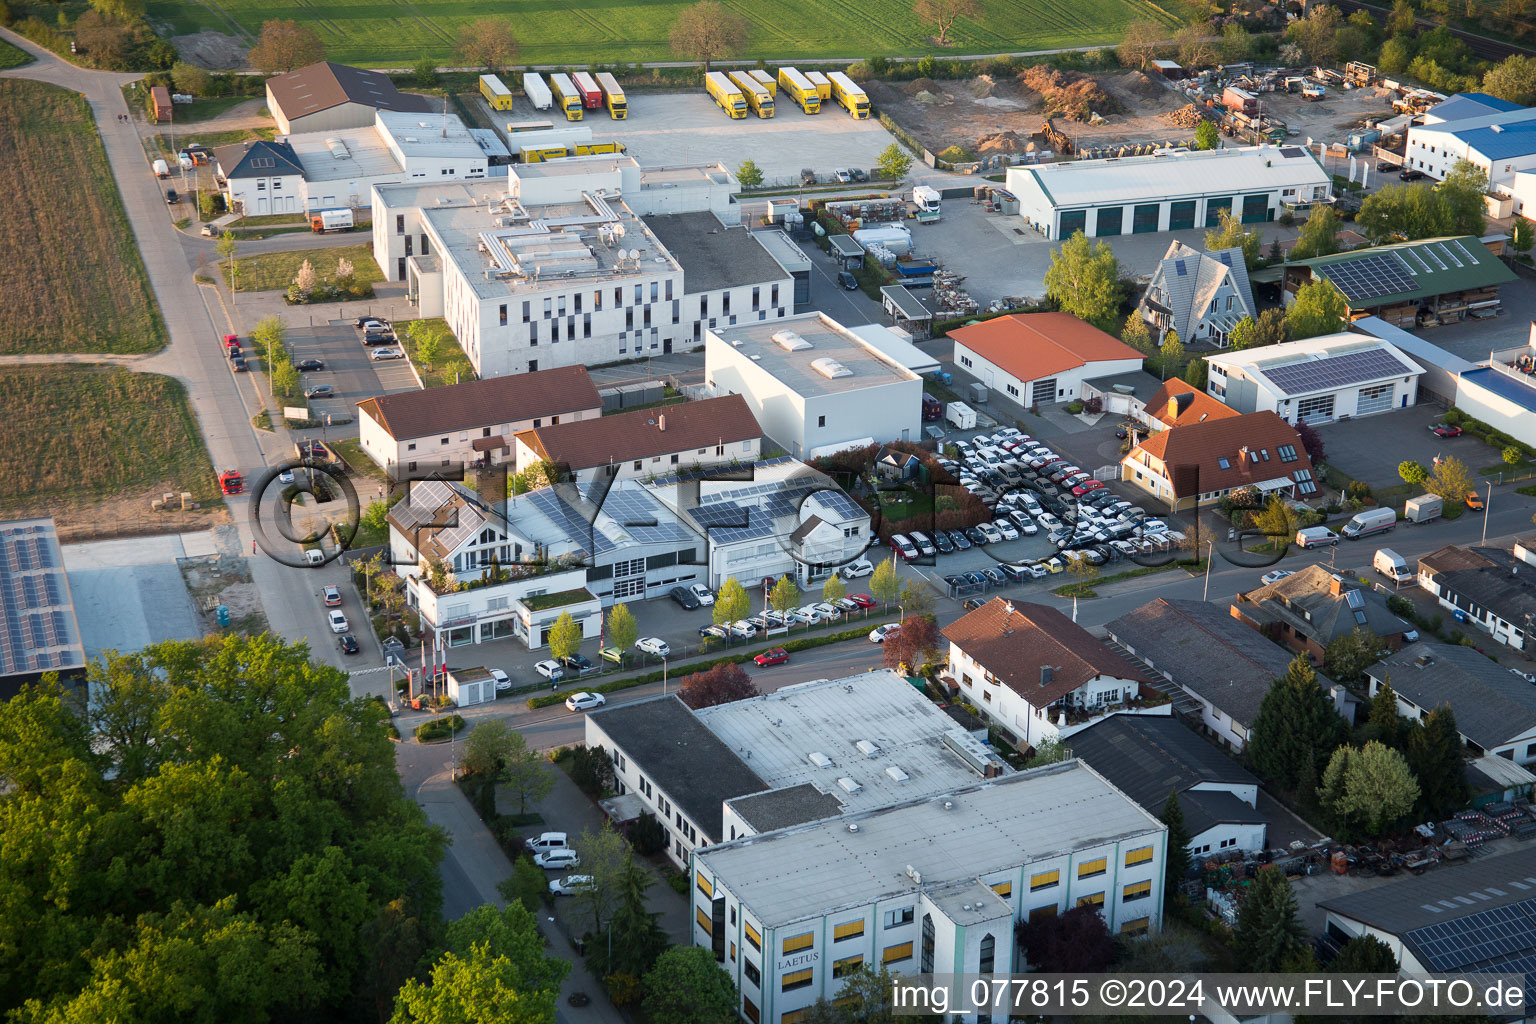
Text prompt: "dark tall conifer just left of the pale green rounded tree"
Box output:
[[1247, 654, 1349, 791]]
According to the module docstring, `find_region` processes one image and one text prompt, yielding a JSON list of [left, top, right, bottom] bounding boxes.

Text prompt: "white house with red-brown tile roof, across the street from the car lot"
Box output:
[[943, 597, 1172, 749]]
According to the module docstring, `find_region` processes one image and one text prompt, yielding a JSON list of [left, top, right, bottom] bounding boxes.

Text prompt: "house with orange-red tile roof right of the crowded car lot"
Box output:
[[1120, 411, 1318, 511]]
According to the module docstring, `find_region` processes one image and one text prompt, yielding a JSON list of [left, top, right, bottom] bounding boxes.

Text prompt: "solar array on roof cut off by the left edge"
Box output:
[[0, 520, 84, 674]]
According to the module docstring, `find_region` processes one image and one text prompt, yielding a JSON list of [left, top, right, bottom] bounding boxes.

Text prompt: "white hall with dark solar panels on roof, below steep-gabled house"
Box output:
[[1206, 332, 1422, 427]]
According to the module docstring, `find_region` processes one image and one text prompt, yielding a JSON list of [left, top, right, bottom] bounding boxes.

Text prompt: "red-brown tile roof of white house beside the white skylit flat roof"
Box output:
[[942, 597, 1146, 708]]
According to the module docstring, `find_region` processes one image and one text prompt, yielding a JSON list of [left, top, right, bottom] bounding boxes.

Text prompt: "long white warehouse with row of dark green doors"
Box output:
[[1008, 146, 1333, 238]]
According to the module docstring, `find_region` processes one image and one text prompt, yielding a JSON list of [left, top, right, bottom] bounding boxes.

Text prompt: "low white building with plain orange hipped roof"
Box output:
[[949, 313, 1143, 407]]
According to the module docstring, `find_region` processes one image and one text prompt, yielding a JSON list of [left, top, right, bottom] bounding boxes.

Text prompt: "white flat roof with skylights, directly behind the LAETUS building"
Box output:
[[694, 669, 1008, 812]]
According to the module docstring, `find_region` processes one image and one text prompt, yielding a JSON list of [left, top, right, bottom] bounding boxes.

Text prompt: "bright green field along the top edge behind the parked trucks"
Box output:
[[149, 0, 1186, 68]]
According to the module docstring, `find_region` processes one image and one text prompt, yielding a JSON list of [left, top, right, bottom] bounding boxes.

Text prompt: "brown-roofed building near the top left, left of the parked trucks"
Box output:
[[267, 60, 432, 135]]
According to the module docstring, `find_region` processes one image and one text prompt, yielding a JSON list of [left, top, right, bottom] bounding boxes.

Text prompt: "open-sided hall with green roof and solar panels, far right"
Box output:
[[1284, 235, 1514, 330]]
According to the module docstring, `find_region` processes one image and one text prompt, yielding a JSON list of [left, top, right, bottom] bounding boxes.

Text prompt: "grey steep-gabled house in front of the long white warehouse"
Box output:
[[1137, 241, 1255, 348]]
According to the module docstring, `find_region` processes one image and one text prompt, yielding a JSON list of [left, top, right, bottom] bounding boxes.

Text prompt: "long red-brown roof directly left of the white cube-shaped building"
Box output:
[[518, 395, 763, 471]]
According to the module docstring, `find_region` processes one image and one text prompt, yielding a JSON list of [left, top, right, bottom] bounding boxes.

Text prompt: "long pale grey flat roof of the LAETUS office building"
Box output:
[[694, 760, 1166, 929]]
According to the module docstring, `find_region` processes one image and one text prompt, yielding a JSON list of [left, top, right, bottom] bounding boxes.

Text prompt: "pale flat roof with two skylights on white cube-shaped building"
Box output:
[[705, 313, 919, 395]]
